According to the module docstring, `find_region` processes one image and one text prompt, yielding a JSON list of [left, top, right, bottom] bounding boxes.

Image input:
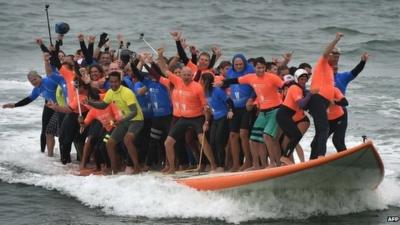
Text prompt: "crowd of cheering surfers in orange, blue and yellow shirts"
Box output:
[[2, 29, 368, 174]]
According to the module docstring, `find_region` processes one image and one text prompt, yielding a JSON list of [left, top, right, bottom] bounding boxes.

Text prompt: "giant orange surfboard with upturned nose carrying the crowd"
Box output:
[[175, 141, 384, 191]]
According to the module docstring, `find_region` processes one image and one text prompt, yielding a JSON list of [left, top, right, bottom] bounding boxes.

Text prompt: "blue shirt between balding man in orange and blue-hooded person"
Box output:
[[207, 88, 228, 120]]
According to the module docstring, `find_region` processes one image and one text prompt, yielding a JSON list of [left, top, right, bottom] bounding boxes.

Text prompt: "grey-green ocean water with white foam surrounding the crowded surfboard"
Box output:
[[0, 0, 400, 224]]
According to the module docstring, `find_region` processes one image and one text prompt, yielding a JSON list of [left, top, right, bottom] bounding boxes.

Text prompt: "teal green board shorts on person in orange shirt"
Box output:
[[250, 108, 278, 143]]
